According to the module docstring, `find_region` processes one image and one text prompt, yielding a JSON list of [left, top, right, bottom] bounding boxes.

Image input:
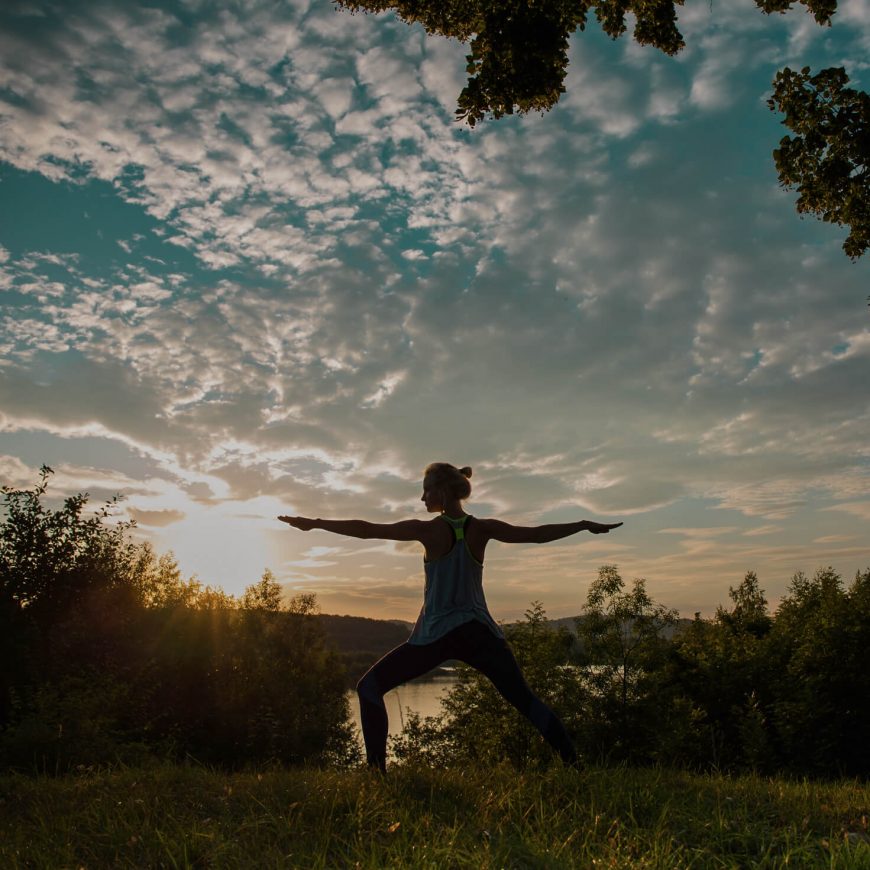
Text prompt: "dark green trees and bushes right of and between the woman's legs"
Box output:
[[393, 566, 870, 776]]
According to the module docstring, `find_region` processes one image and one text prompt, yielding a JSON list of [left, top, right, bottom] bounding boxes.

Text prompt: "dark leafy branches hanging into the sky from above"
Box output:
[[335, 0, 870, 260]]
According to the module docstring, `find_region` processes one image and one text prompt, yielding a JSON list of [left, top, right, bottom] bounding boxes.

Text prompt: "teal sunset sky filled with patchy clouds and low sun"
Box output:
[[0, 0, 870, 620]]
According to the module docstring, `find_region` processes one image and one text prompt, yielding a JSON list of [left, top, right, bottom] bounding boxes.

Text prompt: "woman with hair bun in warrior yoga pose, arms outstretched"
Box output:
[[278, 462, 622, 770]]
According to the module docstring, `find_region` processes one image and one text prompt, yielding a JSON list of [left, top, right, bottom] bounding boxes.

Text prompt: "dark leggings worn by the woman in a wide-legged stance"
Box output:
[[356, 619, 576, 770]]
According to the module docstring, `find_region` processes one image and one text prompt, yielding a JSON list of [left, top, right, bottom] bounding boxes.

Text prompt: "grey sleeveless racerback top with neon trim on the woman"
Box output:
[[408, 514, 504, 646]]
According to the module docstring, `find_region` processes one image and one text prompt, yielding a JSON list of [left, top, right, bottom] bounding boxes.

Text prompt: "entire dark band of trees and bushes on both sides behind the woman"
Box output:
[[0, 468, 870, 776]]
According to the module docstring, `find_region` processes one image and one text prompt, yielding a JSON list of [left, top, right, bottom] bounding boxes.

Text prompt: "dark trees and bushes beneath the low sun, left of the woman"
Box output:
[[0, 467, 358, 772]]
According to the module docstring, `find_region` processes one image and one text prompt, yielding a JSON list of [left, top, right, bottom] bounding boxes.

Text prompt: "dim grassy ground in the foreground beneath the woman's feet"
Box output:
[[0, 766, 870, 870]]
